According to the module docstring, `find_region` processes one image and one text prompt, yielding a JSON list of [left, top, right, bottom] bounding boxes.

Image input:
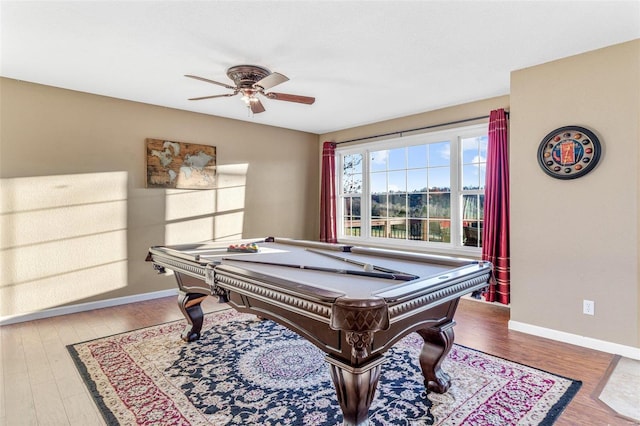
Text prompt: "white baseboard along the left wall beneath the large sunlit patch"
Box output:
[[0, 288, 178, 325]]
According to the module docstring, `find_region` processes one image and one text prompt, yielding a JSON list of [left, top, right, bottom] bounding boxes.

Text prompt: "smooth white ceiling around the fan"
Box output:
[[0, 0, 640, 134]]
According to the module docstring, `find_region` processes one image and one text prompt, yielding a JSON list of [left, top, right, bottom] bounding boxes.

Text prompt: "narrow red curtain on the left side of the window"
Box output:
[[320, 142, 338, 243]]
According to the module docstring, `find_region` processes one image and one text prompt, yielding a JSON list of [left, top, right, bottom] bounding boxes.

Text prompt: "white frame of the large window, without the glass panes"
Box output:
[[336, 123, 488, 258]]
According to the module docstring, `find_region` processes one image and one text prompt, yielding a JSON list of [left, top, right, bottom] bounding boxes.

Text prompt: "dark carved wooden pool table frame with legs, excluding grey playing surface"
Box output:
[[147, 237, 492, 425]]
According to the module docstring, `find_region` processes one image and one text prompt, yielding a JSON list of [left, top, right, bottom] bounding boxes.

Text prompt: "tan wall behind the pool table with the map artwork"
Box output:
[[0, 79, 320, 317]]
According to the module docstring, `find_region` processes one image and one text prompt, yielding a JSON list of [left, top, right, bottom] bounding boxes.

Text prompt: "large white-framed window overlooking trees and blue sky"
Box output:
[[336, 125, 487, 251]]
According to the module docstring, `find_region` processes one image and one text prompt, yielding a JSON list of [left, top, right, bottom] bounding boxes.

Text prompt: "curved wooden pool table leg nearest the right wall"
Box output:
[[417, 321, 455, 393]]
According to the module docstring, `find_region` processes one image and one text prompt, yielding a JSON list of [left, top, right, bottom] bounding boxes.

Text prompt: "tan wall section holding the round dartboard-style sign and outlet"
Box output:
[[510, 40, 640, 347]]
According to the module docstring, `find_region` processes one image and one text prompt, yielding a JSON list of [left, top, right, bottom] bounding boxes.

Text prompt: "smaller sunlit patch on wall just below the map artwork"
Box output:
[[165, 164, 249, 245]]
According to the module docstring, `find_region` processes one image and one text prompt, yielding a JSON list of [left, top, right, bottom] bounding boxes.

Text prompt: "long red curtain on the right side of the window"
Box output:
[[482, 109, 510, 305]]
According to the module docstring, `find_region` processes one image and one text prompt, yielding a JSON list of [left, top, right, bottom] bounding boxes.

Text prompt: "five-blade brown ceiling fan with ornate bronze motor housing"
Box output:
[[185, 65, 316, 114]]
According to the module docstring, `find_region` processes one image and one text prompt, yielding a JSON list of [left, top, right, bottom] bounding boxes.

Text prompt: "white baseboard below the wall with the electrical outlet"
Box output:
[[509, 321, 640, 360]]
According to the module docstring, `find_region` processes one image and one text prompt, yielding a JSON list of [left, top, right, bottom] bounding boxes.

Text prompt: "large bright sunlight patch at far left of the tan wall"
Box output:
[[0, 172, 127, 317]]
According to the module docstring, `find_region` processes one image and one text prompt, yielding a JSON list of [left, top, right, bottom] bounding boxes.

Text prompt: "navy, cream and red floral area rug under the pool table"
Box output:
[[68, 310, 581, 426]]
